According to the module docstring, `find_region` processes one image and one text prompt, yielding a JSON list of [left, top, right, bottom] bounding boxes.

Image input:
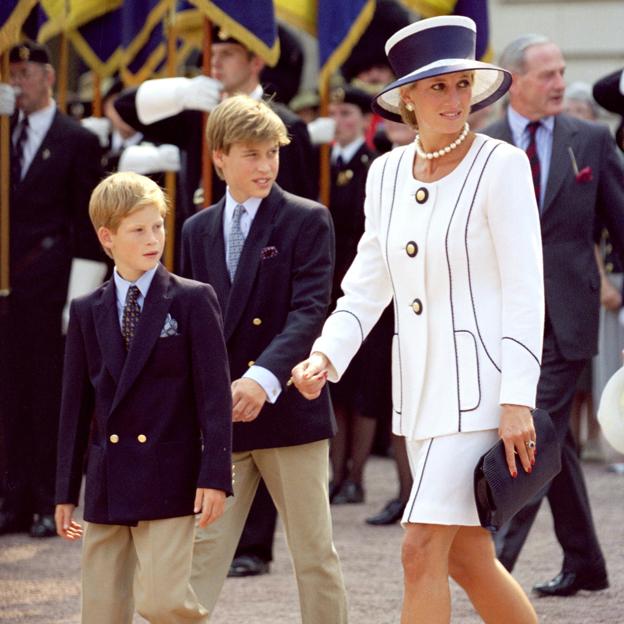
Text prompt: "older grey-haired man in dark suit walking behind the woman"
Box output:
[[485, 35, 624, 596]]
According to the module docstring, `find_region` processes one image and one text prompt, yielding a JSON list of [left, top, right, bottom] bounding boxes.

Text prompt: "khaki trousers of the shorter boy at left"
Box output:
[[81, 516, 208, 624]]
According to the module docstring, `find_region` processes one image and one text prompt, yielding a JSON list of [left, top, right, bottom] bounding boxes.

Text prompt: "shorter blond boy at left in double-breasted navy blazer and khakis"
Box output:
[[56, 173, 232, 624]]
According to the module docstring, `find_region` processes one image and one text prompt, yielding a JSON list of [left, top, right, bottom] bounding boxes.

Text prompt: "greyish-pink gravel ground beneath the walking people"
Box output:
[[0, 457, 624, 624]]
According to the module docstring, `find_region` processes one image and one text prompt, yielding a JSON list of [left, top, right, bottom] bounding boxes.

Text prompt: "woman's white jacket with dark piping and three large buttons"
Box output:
[[313, 135, 544, 439]]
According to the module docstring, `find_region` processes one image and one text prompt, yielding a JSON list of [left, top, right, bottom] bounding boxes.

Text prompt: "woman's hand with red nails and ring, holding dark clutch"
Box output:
[[498, 405, 536, 478]]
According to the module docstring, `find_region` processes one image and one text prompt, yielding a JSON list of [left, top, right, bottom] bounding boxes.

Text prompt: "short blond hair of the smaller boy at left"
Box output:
[[89, 171, 168, 232]]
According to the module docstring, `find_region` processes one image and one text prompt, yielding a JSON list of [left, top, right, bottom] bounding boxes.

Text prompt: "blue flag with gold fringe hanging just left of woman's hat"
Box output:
[[316, 0, 375, 94]]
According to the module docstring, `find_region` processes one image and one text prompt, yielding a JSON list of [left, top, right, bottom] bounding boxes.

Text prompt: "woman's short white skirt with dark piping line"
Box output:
[[401, 429, 498, 526]]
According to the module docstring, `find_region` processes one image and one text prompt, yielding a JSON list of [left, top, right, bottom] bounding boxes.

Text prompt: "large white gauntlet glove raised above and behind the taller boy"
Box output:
[[136, 76, 223, 124]]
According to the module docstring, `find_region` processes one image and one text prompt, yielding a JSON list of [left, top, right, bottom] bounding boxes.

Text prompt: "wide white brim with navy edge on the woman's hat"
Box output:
[[371, 59, 511, 122]]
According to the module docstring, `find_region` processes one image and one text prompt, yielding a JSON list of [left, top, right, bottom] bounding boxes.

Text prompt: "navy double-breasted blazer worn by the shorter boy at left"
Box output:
[[56, 265, 232, 525]]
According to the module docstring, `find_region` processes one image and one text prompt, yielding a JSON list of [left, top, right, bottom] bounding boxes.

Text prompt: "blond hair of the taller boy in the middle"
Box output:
[[206, 95, 290, 178]]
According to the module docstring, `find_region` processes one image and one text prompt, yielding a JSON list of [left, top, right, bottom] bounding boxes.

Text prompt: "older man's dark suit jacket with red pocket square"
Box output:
[[485, 114, 624, 360]]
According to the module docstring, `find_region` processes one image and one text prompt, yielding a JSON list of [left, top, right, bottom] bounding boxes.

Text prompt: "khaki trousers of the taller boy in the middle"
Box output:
[[191, 440, 347, 624]]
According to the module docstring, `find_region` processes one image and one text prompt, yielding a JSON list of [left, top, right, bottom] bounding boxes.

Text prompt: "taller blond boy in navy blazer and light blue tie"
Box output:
[[182, 95, 347, 624]]
